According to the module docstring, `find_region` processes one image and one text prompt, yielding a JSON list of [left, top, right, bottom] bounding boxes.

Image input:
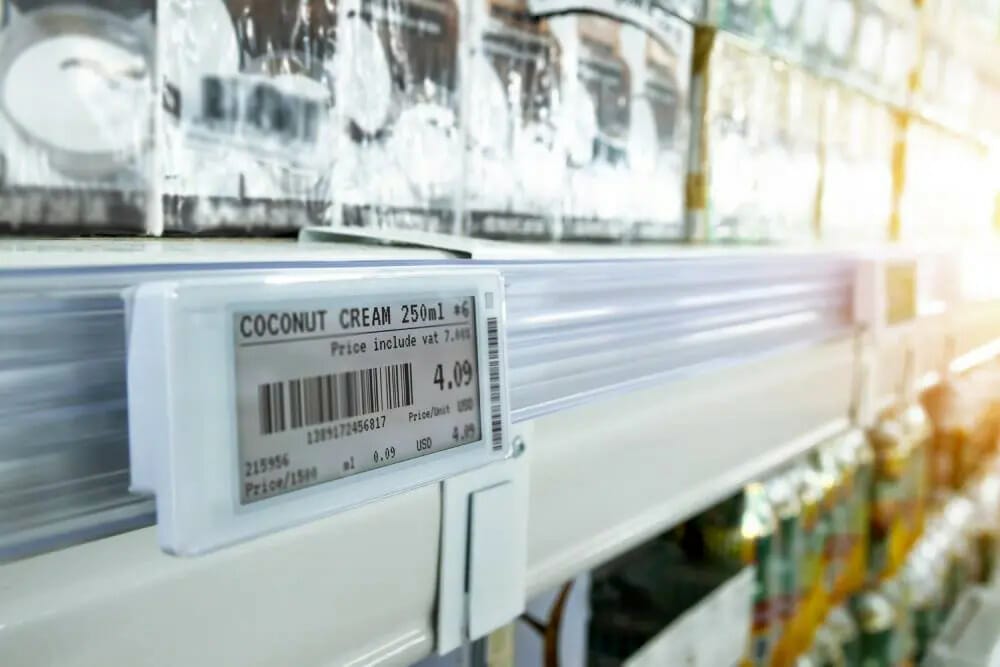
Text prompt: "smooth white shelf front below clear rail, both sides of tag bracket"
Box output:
[[0, 339, 853, 667]]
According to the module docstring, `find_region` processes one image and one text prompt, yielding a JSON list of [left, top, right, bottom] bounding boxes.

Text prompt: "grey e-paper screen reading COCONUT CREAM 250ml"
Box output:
[[232, 295, 503, 504]]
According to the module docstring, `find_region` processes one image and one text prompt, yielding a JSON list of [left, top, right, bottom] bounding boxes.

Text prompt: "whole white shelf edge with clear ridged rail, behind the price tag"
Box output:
[[0, 244, 1000, 666]]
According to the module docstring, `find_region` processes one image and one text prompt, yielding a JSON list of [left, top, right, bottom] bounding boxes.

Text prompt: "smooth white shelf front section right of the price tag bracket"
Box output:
[[528, 338, 855, 594]]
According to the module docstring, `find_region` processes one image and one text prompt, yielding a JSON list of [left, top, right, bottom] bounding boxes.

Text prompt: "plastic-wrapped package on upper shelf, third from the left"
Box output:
[[328, 0, 462, 232]]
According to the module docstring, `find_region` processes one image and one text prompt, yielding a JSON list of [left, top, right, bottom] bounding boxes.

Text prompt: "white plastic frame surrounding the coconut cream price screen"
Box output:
[[128, 266, 511, 555]]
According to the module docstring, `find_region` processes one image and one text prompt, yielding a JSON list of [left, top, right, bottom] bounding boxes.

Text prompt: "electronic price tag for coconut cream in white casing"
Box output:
[[128, 268, 509, 554]]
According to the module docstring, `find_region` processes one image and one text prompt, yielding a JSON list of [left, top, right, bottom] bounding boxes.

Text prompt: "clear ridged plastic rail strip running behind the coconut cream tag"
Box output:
[[0, 242, 854, 561]]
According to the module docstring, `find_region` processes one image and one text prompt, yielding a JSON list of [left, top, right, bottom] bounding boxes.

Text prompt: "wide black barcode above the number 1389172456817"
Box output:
[[257, 362, 416, 435]]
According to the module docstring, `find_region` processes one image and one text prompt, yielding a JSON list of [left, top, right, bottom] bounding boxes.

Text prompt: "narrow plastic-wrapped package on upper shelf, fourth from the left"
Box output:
[[463, 0, 566, 239]]
